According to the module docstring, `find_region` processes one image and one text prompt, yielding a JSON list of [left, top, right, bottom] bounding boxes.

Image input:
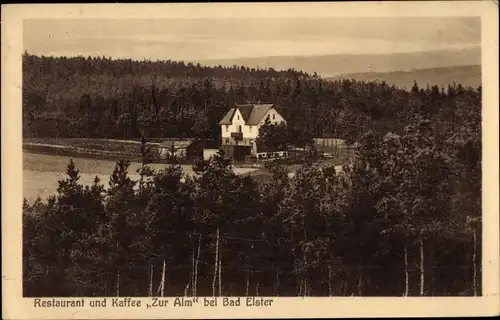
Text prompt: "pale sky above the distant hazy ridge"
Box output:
[[23, 17, 481, 61]]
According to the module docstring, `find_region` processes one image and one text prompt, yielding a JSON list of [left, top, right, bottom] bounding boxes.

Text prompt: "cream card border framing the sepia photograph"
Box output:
[[1, 1, 500, 319]]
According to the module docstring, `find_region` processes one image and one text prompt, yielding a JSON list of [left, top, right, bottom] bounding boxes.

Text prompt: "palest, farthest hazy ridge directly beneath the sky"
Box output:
[[197, 47, 481, 77]]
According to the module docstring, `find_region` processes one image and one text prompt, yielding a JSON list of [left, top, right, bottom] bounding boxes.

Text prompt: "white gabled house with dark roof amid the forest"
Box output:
[[219, 104, 286, 153]]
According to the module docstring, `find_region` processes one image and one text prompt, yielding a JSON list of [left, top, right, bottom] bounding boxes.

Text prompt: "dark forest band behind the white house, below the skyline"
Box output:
[[23, 53, 481, 142]]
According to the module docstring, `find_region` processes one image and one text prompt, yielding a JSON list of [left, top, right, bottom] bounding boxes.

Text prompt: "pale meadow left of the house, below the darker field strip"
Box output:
[[23, 151, 256, 202]]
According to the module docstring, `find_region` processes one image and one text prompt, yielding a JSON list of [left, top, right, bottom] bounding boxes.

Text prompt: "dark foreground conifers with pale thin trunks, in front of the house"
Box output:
[[23, 105, 481, 296]]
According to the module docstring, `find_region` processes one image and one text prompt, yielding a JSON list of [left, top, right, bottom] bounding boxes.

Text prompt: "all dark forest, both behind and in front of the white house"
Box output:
[[23, 55, 482, 297]]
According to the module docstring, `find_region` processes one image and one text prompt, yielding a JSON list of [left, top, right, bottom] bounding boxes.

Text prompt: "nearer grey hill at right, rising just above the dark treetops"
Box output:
[[327, 65, 481, 89]]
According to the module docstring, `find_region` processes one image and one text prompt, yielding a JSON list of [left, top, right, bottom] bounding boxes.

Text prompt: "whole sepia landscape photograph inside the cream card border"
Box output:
[[2, 3, 498, 320]]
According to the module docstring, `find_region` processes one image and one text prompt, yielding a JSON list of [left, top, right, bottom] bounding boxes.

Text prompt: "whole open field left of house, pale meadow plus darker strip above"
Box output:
[[23, 138, 346, 202]]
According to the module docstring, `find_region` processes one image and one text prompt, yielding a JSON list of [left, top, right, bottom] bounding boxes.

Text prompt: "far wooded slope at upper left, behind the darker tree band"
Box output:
[[23, 53, 307, 101]]
